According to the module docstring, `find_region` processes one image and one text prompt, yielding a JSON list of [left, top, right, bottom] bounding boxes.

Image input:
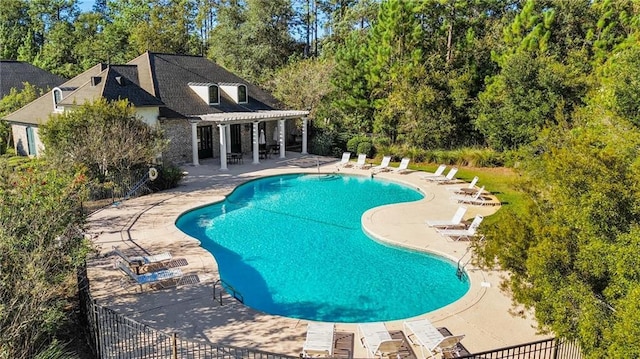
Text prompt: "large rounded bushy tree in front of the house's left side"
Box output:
[[40, 99, 165, 182]]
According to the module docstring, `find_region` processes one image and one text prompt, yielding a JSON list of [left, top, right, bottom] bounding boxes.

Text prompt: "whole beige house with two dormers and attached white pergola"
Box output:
[[1, 52, 308, 170]]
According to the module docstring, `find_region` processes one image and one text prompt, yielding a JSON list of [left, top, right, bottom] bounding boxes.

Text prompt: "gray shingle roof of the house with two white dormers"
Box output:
[[5, 52, 282, 124]]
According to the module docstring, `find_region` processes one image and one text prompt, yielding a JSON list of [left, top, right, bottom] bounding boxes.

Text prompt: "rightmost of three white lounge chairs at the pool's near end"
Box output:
[[403, 319, 464, 358]]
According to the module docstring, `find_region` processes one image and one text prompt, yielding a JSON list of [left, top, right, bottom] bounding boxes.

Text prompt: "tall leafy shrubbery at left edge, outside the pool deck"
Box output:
[[0, 158, 88, 359]]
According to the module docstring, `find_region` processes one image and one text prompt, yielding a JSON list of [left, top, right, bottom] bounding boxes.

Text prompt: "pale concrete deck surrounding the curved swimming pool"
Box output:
[[87, 152, 549, 358]]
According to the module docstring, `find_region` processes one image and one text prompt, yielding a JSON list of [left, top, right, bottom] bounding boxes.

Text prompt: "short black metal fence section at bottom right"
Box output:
[[459, 338, 582, 359]]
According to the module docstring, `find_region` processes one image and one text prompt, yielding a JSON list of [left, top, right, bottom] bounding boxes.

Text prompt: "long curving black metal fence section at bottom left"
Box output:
[[78, 267, 299, 359]]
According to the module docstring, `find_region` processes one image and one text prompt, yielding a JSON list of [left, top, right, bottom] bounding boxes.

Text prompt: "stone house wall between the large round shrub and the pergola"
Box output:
[[159, 118, 192, 164]]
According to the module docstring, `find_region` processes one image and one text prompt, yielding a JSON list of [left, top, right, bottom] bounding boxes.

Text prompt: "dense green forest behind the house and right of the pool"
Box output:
[[0, 0, 640, 358]]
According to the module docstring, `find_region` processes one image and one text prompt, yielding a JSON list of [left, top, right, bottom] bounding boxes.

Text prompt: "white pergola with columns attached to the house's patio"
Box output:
[[191, 110, 309, 170]]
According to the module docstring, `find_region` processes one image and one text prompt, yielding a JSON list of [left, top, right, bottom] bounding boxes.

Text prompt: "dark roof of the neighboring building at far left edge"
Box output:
[[0, 60, 66, 98]]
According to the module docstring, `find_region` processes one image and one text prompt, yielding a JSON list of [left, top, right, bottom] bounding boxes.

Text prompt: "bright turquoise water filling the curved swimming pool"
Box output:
[[176, 174, 469, 323]]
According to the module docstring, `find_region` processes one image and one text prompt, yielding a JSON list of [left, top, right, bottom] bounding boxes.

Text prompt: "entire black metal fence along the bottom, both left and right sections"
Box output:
[[78, 267, 582, 359]]
